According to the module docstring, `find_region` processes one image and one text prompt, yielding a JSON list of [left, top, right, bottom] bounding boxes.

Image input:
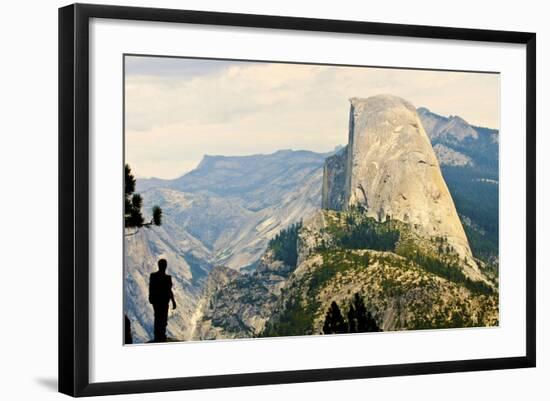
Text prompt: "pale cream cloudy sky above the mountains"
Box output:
[[125, 56, 499, 179]]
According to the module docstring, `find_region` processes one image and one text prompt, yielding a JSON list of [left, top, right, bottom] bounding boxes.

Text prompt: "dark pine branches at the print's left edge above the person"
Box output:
[[124, 164, 162, 235]]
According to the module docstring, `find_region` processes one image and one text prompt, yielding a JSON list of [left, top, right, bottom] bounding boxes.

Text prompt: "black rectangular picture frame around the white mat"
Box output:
[[58, 4, 536, 396]]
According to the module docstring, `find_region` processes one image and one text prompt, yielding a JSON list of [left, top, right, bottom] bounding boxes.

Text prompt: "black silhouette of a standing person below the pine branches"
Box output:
[[149, 259, 176, 342]]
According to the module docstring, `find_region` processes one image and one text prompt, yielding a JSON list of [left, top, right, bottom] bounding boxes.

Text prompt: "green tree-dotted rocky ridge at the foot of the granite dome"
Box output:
[[262, 208, 498, 336]]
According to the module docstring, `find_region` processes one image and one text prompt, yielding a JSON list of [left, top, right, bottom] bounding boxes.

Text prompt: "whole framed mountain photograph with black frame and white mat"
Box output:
[[59, 4, 536, 396]]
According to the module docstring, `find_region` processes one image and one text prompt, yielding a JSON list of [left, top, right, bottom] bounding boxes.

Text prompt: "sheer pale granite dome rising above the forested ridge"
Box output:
[[323, 95, 482, 280]]
